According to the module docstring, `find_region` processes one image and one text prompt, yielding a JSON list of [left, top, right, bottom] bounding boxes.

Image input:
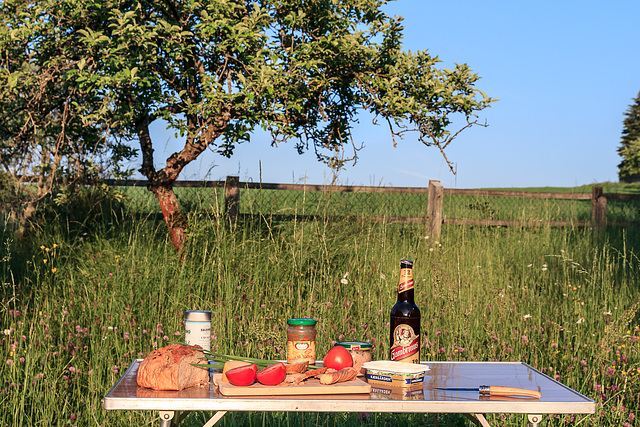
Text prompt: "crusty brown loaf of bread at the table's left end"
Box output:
[[137, 344, 209, 390]]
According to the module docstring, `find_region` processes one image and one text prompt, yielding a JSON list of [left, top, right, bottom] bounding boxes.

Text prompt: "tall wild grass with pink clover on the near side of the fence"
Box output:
[[0, 185, 640, 427]]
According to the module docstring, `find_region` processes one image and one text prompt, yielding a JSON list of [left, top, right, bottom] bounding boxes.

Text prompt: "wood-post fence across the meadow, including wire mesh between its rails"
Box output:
[[106, 176, 640, 241]]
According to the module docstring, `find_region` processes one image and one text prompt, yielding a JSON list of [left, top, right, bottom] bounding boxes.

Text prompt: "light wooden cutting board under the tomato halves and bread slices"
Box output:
[[213, 374, 371, 396]]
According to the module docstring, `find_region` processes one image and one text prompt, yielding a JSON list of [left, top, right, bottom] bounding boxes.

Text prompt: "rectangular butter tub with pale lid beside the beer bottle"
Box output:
[[362, 360, 429, 388]]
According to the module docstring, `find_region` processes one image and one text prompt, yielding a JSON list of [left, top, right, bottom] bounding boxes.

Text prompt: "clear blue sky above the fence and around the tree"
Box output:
[[145, 0, 640, 188]]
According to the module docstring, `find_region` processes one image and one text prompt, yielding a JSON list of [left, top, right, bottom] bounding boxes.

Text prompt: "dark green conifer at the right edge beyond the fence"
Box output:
[[618, 92, 640, 181]]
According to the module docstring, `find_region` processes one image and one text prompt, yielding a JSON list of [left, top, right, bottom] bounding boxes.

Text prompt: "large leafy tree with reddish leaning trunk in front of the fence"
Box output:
[[1, 0, 493, 254]]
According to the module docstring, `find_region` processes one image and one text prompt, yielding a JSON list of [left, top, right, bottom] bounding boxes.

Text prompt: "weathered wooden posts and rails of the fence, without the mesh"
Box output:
[[107, 176, 640, 239]]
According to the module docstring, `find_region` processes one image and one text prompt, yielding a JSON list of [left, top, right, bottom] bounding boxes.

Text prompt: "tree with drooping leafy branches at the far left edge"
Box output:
[[0, 1, 135, 238]]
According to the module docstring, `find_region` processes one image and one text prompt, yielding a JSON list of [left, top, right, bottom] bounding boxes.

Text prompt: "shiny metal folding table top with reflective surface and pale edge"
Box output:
[[103, 359, 596, 414]]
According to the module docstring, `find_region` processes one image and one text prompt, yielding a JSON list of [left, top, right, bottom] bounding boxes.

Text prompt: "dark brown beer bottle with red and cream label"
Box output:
[[389, 259, 420, 363]]
